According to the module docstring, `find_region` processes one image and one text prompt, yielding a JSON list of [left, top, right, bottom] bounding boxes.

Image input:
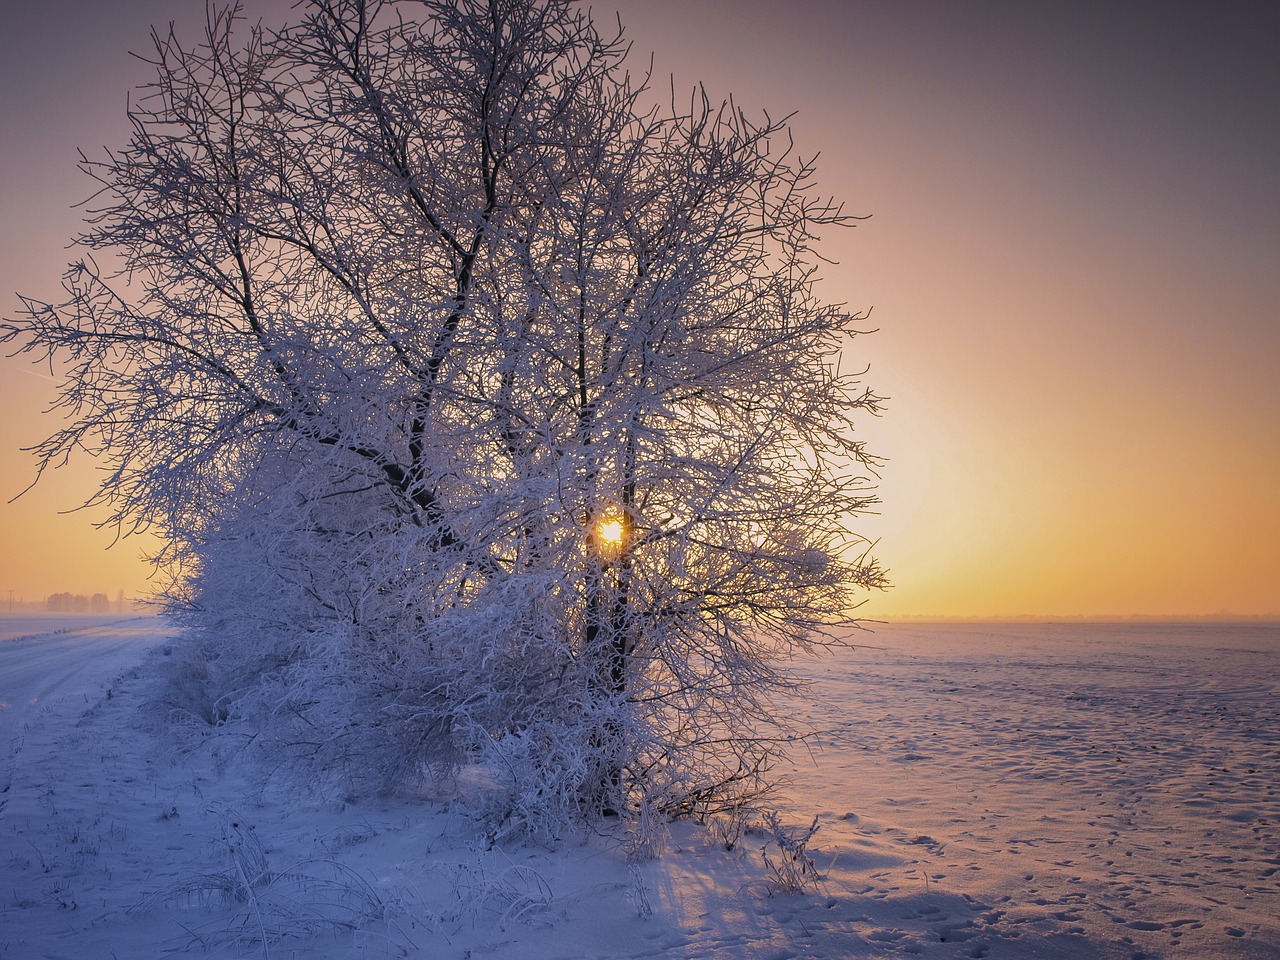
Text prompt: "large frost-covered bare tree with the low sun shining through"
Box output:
[[3, 0, 882, 831]]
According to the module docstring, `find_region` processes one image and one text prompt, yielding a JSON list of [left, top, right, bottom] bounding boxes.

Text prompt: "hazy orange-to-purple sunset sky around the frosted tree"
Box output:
[[0, 0, 1280, 617]]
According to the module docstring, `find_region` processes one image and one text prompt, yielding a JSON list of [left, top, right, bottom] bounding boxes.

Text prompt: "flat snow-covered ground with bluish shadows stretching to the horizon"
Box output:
[[0, 618, 1280, 960]]
